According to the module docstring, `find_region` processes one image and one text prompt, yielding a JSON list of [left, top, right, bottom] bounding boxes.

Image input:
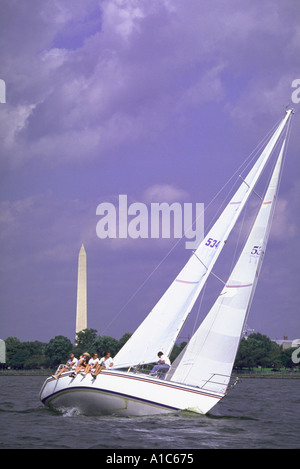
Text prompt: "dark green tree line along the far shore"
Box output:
[[0, 329, 300, 378]]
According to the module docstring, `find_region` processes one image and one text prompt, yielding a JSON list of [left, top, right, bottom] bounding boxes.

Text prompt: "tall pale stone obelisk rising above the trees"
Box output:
[[76, 244, 87, 334]]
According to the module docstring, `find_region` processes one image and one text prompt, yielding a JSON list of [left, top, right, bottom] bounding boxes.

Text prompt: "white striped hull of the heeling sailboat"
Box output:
[[40, 370, 224, 416]]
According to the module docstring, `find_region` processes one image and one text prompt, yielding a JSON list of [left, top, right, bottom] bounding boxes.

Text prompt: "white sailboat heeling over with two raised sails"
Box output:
[[40, 109, 294, 416]]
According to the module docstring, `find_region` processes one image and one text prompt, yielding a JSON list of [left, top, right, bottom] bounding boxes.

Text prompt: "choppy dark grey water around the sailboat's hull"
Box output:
[[0, 376, 300, 450]]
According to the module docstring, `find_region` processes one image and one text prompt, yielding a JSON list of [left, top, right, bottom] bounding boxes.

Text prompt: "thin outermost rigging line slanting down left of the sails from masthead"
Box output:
[[103, 113, 288, 332]]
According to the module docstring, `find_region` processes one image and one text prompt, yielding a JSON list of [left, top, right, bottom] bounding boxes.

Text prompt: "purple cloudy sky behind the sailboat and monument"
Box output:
[[0, 0, 300, 342]]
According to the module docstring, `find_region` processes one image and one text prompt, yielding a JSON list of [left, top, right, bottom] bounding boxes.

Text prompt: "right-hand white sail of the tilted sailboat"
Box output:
[[171, 140, 285, 393]]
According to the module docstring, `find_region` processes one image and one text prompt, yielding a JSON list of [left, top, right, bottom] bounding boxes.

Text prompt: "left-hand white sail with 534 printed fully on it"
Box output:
[[114, 110, 292, 368]]
